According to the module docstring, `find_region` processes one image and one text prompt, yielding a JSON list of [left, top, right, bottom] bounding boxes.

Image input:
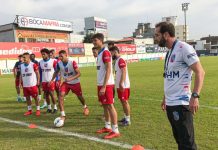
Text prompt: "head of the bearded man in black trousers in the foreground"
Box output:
[[155, 22, 175, 47]]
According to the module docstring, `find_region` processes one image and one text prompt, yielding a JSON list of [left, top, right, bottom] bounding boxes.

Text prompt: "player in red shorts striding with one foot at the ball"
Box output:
[[52, 50, 89, 120]]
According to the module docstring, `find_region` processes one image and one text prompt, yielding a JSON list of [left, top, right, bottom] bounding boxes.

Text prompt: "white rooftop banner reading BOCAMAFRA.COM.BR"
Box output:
[[17, 16, 73, 32]]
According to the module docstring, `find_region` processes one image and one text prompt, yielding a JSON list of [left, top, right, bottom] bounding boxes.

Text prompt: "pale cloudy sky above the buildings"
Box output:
[[0, 0, 218, 40]]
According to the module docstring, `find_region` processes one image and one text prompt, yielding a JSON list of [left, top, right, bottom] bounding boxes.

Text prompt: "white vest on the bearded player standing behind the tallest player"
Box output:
[[115, 57, 130, 88]]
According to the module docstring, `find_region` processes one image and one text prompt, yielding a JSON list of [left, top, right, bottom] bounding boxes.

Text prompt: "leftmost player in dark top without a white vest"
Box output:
[[13, 55, 23, 102]]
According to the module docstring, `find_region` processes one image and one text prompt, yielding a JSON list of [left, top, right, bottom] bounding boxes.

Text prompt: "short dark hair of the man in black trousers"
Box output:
[[155, 22, 175, 37]]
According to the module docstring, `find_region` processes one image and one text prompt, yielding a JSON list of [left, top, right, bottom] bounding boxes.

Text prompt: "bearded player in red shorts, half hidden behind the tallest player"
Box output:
[[109, 46, 131, 126]]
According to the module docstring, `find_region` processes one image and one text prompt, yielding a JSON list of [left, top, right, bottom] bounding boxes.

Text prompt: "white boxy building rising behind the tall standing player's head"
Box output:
[[85, 17, 108, 40]]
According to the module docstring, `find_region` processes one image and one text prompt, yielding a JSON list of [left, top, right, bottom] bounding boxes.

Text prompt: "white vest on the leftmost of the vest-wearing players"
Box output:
[[21, 62, 37, 87]]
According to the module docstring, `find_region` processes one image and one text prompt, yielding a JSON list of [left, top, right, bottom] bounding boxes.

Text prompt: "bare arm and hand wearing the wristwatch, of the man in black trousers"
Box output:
[[189, 61, 205, 114]]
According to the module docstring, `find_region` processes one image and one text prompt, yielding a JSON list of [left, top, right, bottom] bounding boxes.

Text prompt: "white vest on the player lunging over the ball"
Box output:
[[58, 60, 80, 84]]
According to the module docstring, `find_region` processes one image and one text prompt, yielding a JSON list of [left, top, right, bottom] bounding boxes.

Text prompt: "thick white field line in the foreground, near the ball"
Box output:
[[0, 117, 149, 150]]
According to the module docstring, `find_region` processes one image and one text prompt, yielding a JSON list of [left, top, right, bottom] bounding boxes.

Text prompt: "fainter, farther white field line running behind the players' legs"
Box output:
[[0, 95, 218, 110]]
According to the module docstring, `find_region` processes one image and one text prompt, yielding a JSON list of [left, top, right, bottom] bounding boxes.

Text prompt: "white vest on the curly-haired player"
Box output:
[[39, 58, 56, 82]]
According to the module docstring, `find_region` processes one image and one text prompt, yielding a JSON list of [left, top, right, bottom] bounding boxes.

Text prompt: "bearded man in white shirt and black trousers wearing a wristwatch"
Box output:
[[155, 22, 205, 150]]
